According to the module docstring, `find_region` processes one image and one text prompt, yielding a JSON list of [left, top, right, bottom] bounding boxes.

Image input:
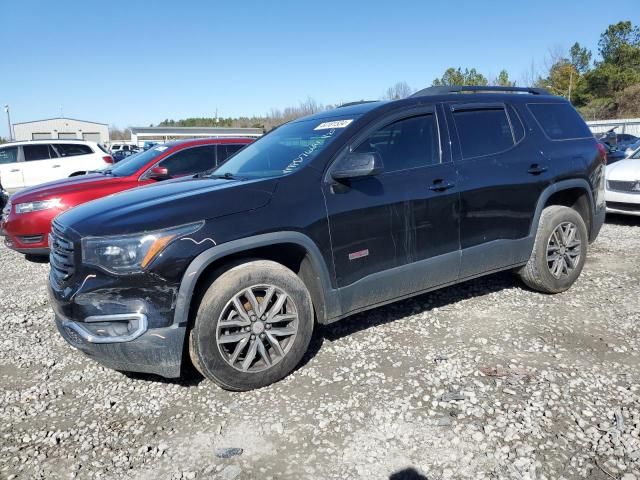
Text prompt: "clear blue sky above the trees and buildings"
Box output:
[[0, 0, 640, 137]]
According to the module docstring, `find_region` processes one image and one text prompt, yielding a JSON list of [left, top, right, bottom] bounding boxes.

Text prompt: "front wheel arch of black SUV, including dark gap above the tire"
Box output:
[[173, 232, 338, 326]]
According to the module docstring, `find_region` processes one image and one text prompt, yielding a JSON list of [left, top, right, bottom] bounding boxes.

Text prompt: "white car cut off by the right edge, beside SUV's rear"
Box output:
[[605, 148, 640, 216]]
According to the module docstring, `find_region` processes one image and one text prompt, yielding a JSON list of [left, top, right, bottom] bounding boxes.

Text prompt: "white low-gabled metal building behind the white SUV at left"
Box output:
[[13, 117, 109, 143]]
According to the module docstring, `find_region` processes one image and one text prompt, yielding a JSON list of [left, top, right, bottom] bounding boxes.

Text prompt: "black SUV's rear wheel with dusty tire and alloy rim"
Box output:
[[517, 205, 588, 293]]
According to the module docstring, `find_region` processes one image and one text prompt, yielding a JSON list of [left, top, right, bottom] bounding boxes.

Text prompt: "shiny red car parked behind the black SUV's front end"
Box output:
[[0, 138, 253, 256]]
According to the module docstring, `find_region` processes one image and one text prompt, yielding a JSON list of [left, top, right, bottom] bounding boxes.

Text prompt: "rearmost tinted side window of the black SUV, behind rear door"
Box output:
[[527, 103, 592, 140]]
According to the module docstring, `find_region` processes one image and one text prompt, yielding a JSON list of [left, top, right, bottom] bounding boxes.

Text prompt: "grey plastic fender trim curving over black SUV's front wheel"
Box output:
[[173, 231, 339, 327]]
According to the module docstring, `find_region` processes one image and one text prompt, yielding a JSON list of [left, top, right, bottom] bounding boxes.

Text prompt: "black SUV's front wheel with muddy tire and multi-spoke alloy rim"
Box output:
[[189, 260, 314, 391]]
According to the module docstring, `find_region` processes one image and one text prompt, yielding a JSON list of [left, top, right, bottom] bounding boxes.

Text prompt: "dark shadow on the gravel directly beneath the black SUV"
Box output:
[[121, 271, 523, 388]]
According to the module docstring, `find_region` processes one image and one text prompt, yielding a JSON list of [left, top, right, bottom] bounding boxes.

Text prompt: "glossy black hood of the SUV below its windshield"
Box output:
[[56, 177, 278, 237]]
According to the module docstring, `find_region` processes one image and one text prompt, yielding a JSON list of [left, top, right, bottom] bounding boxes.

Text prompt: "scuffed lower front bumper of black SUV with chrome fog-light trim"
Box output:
[[49, 287, 186, 378]]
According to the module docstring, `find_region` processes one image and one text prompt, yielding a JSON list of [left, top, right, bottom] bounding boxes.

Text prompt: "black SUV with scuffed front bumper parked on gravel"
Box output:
[[50, 87, 606, 390]]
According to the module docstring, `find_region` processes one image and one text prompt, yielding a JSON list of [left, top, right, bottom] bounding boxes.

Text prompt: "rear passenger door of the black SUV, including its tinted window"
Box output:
[[447, 103, 552, 278]]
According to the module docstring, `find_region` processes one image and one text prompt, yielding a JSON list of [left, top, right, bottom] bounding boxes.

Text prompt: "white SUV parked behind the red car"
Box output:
[[0, 140, 113, 192]]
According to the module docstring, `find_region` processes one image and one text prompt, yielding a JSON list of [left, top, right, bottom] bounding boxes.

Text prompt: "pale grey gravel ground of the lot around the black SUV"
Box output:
[[0, 217, 640, 480]]
